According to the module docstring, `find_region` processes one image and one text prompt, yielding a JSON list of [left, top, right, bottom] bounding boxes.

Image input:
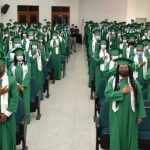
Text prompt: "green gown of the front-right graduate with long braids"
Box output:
[[105, 79, 146, 150]]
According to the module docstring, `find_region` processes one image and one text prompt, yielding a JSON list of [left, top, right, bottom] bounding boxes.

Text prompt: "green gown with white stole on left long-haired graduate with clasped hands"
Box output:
[[9, 64, 31, 124]]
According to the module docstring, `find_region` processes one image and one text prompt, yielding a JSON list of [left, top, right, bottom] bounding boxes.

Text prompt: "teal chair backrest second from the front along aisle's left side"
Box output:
[[30, 77, 38, 102]]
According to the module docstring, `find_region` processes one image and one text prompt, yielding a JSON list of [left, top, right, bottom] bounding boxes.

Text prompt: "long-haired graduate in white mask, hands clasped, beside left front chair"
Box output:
[[9, 48, 31, 124]]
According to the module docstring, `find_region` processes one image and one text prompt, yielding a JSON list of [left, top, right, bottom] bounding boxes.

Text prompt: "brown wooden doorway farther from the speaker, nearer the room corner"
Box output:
[[51, 6, 70, 26]]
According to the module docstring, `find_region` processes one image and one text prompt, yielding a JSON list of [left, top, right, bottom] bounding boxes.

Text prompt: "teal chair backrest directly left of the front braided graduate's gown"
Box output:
[[99, 100, 110, 128]]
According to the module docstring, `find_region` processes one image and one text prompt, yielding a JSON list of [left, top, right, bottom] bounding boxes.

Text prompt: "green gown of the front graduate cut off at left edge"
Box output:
[[0, 76, 19, 150]]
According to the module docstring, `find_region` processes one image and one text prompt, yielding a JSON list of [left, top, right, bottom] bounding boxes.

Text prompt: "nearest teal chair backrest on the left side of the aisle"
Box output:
[[15, 97, 25, 126]]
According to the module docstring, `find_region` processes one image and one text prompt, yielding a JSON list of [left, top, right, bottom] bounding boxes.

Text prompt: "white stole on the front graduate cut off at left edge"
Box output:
[[1, 73, 9, 113]]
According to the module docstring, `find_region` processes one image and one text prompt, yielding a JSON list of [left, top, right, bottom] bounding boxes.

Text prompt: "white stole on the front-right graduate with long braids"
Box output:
[[112, 76, 135, 112]]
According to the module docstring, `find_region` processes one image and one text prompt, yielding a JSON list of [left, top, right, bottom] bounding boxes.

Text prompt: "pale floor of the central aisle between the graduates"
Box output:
[[17, 45, 95, 150]]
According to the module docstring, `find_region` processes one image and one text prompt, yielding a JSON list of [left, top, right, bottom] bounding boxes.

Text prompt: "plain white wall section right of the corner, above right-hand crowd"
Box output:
[[80, 0, 127, 32]]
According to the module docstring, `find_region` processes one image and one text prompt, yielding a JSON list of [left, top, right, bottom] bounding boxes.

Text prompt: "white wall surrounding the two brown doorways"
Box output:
[[2, 0, 79, 25]]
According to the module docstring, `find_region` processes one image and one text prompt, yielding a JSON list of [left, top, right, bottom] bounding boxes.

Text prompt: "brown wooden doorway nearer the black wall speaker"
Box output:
[[18, 6, 39, 24]]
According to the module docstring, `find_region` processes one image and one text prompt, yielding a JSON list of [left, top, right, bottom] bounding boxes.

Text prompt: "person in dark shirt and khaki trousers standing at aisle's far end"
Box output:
[[70, 24, 77, 52]]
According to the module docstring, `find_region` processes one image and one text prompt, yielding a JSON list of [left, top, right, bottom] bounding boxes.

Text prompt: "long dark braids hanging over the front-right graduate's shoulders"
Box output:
[[114, 65, 137, 105]]
